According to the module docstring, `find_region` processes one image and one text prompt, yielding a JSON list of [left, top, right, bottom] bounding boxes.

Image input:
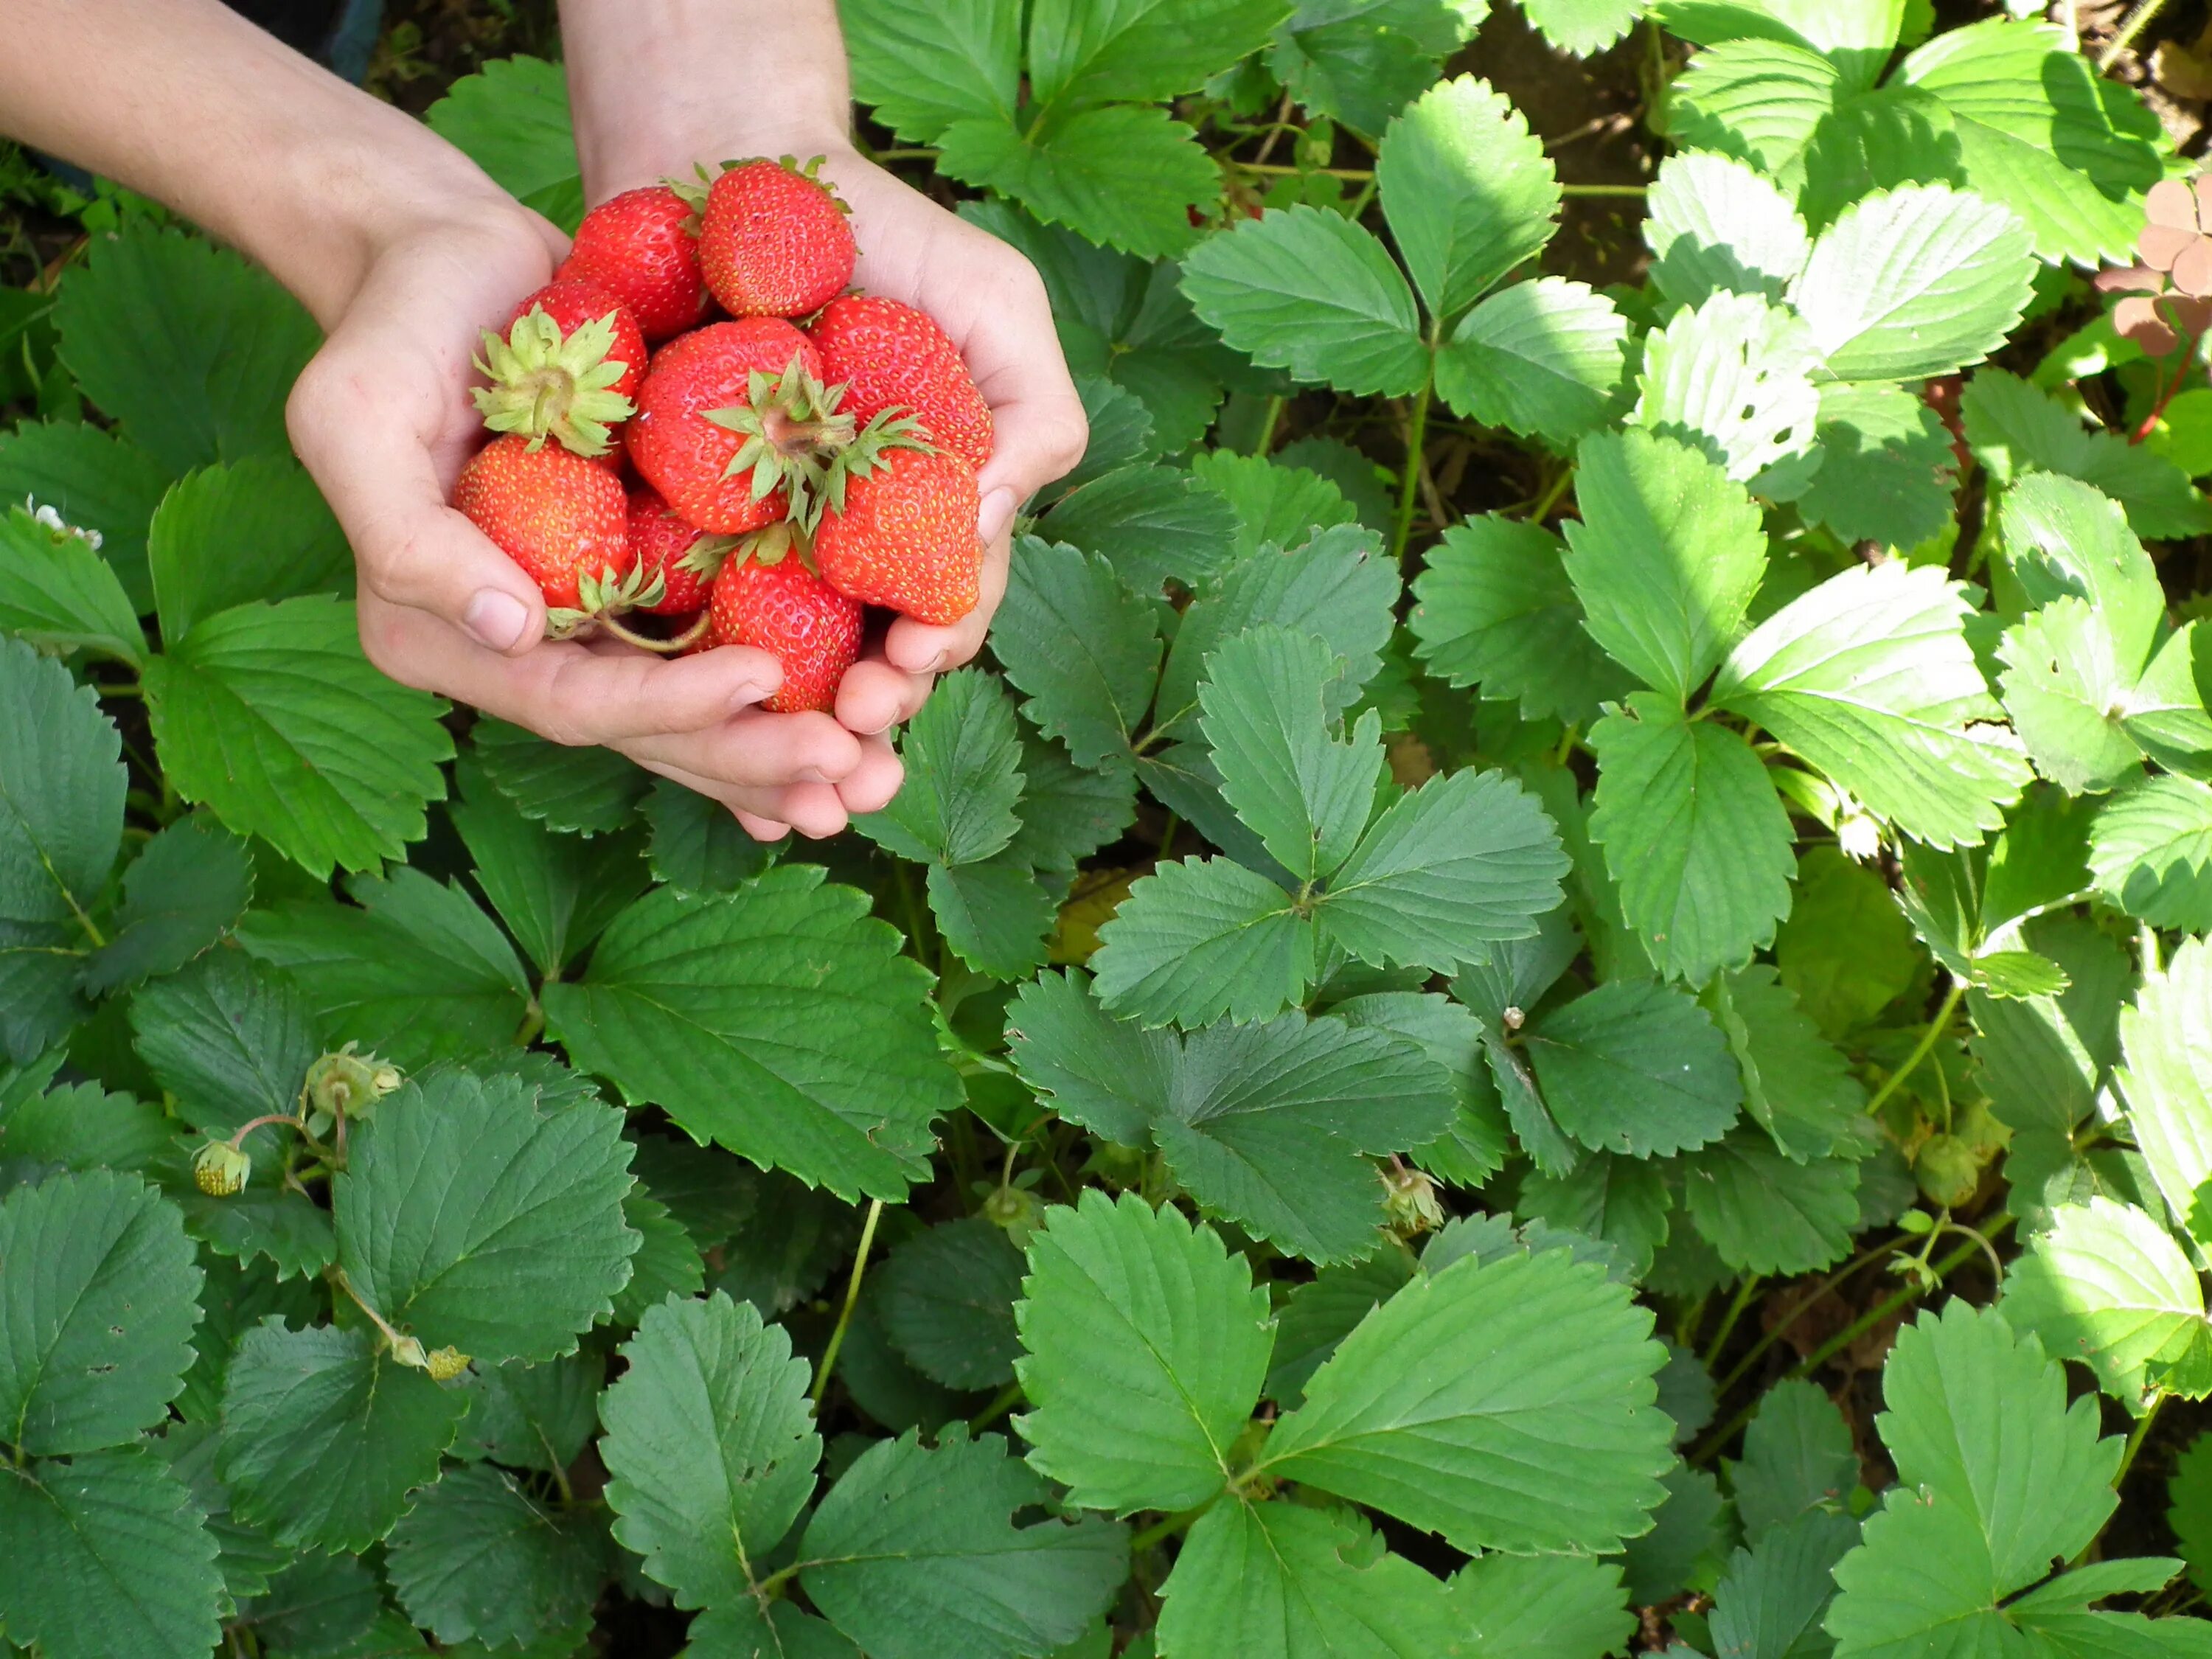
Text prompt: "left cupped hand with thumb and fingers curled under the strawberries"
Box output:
[[288, 200, 900, 838]]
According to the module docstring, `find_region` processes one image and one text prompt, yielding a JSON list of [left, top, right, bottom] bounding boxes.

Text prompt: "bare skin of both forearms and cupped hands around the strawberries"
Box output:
[[0, 0, 1086, 838]]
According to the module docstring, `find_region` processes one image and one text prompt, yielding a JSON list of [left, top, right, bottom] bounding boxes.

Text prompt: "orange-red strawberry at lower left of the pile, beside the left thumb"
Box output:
[[453, 436, 637, 635]]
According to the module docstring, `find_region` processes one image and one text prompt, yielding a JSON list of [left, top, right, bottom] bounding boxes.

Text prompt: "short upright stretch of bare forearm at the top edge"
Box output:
[[560, 0, 852, 201]]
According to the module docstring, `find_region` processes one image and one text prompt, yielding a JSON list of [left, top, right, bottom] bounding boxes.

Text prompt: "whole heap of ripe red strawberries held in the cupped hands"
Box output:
[[453, 157, 991, 712]]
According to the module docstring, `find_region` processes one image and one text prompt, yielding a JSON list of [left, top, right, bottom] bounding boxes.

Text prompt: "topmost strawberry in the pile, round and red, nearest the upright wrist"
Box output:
[[699, 157, 858, 316]]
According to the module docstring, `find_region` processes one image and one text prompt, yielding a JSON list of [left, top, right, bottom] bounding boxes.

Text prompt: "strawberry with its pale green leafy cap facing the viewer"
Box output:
[[469, 281, 646, 467]]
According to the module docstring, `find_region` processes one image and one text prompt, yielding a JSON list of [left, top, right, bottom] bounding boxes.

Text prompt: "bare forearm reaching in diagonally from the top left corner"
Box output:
[[0, 0, 504, 325]]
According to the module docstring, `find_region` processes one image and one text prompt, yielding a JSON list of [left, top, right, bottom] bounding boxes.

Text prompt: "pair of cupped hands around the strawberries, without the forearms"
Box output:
[[288, 144, 1086, 841]]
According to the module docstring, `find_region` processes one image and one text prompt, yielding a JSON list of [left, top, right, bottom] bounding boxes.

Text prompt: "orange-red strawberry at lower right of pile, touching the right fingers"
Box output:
[[814, 447, 982, 626]]
